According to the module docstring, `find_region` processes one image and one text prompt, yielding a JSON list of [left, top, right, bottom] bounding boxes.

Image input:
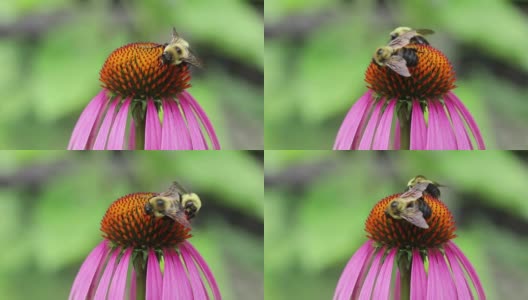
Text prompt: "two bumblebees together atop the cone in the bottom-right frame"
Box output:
[[385, 175, 442, 229]]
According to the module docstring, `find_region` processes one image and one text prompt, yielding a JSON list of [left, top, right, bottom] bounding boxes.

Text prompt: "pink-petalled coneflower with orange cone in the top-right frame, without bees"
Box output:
[[334, 35, 485, 150]]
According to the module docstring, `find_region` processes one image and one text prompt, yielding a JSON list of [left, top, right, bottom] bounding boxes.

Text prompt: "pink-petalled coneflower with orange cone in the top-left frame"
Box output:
[[68, 29, 220, 150]]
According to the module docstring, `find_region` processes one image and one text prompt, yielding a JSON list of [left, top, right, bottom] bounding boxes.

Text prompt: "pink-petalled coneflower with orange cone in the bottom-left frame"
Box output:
[[69, 182, 222, 300]]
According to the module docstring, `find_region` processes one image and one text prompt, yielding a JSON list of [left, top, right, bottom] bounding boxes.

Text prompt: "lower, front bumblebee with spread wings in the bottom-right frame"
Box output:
[[385, 182, 432, 229]]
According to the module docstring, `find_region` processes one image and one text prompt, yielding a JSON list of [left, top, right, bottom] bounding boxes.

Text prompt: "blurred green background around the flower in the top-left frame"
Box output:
[[0, 0, 264, 149]]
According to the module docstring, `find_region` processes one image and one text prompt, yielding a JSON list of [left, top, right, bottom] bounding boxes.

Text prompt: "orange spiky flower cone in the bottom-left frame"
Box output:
[[101, 193, 191, 249]]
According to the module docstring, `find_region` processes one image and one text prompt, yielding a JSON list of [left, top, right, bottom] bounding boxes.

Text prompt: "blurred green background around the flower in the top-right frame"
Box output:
[[264, 0, 528, 149]]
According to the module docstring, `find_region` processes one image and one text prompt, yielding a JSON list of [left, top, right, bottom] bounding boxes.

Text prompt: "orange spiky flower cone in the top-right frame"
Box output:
[[365, 44, 456, 99]]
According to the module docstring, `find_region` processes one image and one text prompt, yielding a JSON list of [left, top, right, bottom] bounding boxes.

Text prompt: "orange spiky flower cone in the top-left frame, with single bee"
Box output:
[[100, 43, 191, 99]]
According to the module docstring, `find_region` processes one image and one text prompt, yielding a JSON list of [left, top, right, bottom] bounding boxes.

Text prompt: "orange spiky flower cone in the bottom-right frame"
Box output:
[[365, 194, 456, 249]]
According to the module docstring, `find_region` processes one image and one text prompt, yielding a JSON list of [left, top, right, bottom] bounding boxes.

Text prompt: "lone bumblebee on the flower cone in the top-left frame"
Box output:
[[160, 27, 202, 67]]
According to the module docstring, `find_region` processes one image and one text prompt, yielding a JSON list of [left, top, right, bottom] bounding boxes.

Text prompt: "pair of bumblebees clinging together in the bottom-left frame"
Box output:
[[145, 182, 202, 227]]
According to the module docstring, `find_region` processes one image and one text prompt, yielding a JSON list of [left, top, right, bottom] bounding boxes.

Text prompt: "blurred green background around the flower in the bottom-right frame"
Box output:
[[264, 151, 528, 300]]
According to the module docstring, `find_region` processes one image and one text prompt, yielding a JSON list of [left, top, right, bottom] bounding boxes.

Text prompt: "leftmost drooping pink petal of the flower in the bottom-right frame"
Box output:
[[333, 241, 376, 300]]
